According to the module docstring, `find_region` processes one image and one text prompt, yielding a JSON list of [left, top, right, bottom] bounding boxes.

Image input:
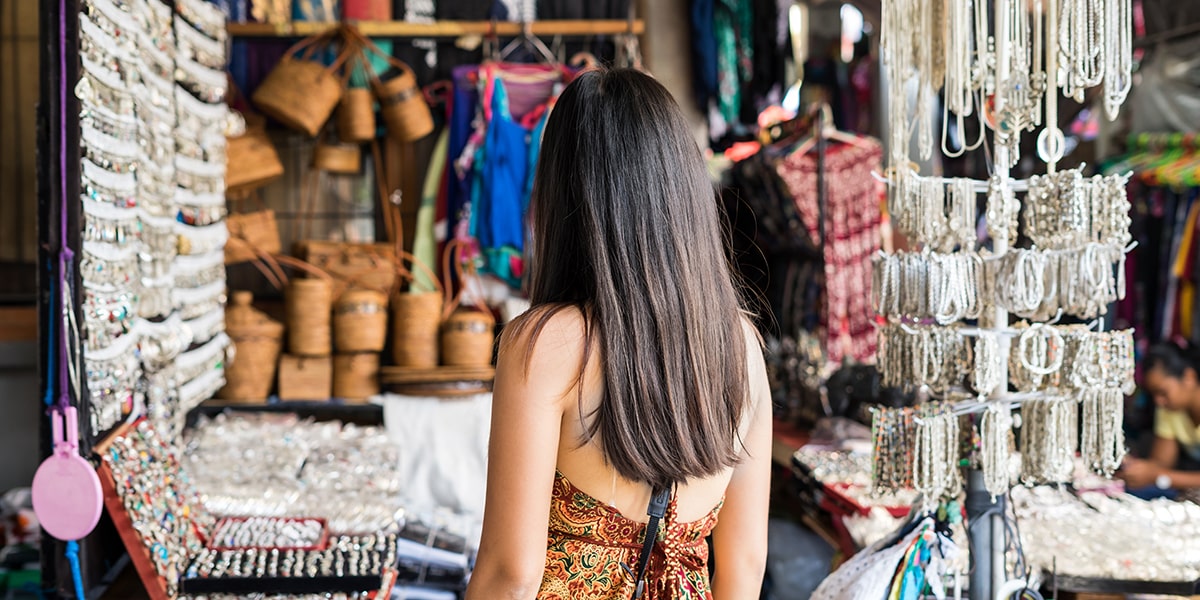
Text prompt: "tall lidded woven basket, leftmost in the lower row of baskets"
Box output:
[[217, 292, 283, 403]]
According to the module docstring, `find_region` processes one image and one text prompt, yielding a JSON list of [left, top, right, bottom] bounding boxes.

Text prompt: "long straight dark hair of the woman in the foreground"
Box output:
[[518, 70, 749, 486]]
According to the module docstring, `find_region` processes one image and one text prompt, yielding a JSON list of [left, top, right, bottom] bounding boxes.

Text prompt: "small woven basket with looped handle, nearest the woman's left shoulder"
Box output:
[[440, 241, 496, 367]]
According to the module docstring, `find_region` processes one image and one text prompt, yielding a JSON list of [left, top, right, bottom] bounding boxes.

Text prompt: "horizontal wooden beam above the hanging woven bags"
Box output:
[[228, 19, 646, 37]]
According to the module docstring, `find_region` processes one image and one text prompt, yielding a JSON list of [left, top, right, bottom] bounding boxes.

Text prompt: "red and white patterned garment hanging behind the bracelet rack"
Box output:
[[779, 138, 883, 364]]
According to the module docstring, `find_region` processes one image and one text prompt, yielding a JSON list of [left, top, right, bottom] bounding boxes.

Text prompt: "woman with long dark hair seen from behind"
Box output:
[[467, 70, 770, 600]]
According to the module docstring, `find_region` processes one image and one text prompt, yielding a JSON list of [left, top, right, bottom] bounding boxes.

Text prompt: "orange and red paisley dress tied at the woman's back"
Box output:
[[538, 472, 724, 600]]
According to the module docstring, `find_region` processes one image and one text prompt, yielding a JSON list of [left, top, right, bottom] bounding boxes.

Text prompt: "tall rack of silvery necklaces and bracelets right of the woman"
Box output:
[[872, 0, 1134, 600]]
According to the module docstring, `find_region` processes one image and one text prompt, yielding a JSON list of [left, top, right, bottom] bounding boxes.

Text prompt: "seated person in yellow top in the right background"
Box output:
[[1117, 342, 1200, 492]]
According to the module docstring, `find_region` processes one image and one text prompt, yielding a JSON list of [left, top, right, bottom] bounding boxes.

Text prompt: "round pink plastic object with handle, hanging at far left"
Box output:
[[32, 407, 104, 541]]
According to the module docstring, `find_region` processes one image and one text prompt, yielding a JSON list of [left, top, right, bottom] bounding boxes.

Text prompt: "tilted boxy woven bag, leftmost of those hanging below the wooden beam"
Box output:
[[253, 34, 349, 137]]
